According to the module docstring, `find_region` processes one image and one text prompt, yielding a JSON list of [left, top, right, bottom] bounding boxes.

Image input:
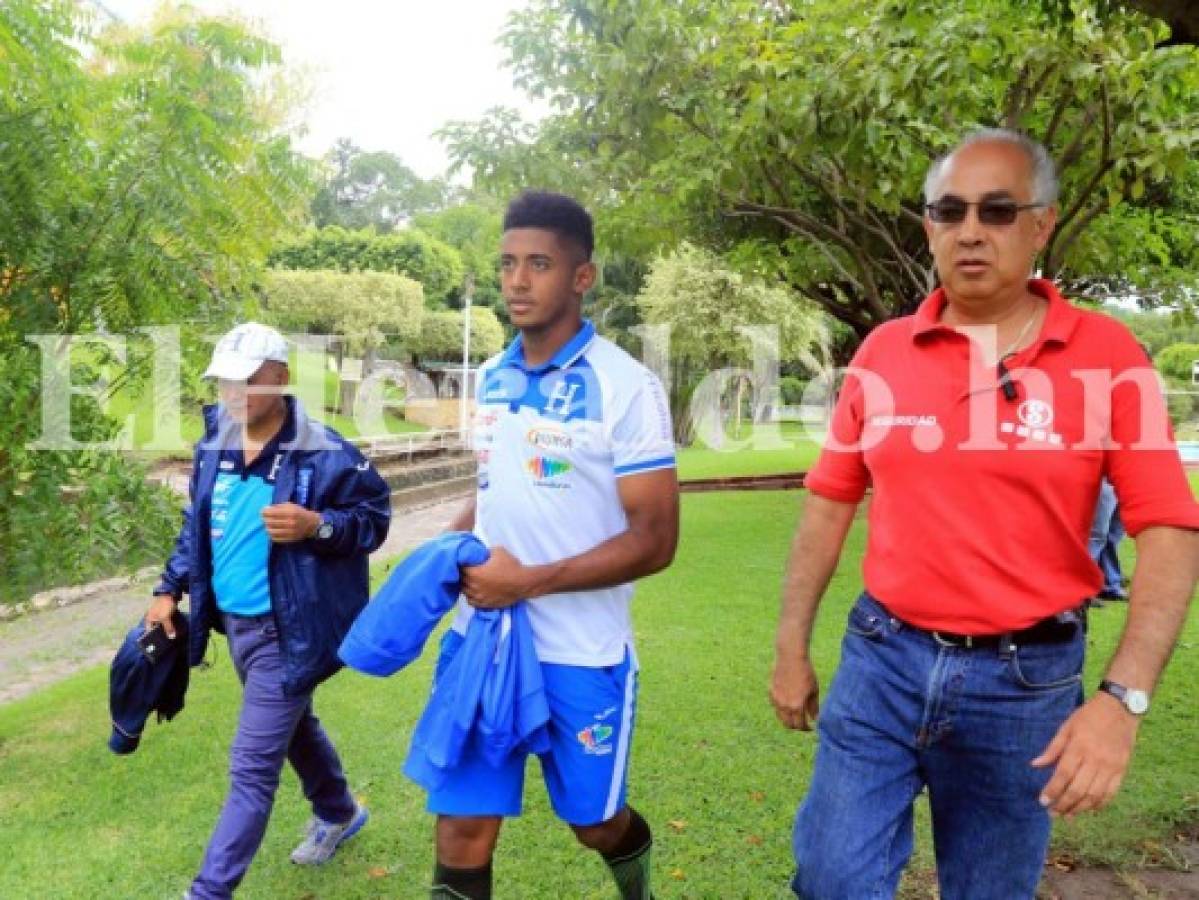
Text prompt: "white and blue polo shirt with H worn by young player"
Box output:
[[453, 322, 675, 666]]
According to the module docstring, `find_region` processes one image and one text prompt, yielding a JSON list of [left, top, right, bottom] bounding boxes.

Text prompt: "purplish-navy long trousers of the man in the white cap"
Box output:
[[191, 614, 355, 900]]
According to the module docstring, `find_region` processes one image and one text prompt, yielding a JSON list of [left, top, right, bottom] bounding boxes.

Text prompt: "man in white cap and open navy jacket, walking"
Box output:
[[146, 322, 391, 900]]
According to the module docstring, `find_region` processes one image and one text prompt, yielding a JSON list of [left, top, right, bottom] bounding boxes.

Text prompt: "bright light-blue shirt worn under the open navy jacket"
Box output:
[[209, 415, 295, 616]]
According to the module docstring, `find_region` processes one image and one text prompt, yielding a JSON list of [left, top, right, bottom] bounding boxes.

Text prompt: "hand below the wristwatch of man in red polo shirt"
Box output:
[[1032, 693, 1140, 816]]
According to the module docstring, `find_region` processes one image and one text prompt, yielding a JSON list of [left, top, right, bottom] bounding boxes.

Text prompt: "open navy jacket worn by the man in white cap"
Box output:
[[155, 397, 391, 696]]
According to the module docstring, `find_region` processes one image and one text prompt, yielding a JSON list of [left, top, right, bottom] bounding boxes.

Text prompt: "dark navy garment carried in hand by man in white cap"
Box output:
[[108, 612, 187, 755]]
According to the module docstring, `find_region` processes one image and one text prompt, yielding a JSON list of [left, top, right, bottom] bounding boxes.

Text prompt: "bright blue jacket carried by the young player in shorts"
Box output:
[[339, 532, 549, 791]]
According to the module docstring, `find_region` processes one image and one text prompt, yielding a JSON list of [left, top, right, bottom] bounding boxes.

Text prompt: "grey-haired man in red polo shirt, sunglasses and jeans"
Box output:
[[771, 129, 1199, 900]]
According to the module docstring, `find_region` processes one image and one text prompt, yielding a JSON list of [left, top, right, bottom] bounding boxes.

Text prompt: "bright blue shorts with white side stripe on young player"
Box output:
[[428, 632, 637, 826]]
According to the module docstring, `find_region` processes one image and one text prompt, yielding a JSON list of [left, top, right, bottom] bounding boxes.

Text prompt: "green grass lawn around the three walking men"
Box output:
[[0, 493, 1199, 900]]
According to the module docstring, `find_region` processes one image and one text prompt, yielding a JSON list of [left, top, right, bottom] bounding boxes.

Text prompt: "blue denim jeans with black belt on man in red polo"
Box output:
[[791, 594, 1085, 900]]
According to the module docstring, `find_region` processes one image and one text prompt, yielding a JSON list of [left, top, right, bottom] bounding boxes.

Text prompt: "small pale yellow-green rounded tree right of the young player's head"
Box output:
[[637, 243, 829, 442]]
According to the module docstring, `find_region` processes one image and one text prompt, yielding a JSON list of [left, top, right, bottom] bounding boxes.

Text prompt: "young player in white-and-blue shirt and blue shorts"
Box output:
[[428, 193, 679, 900]]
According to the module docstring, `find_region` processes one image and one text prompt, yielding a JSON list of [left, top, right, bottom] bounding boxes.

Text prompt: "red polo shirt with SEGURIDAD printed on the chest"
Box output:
[[806, 280, 1199, 634]]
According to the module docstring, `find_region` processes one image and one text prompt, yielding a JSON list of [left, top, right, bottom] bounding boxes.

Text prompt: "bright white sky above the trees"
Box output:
[[100, 0, 544, 177]]
